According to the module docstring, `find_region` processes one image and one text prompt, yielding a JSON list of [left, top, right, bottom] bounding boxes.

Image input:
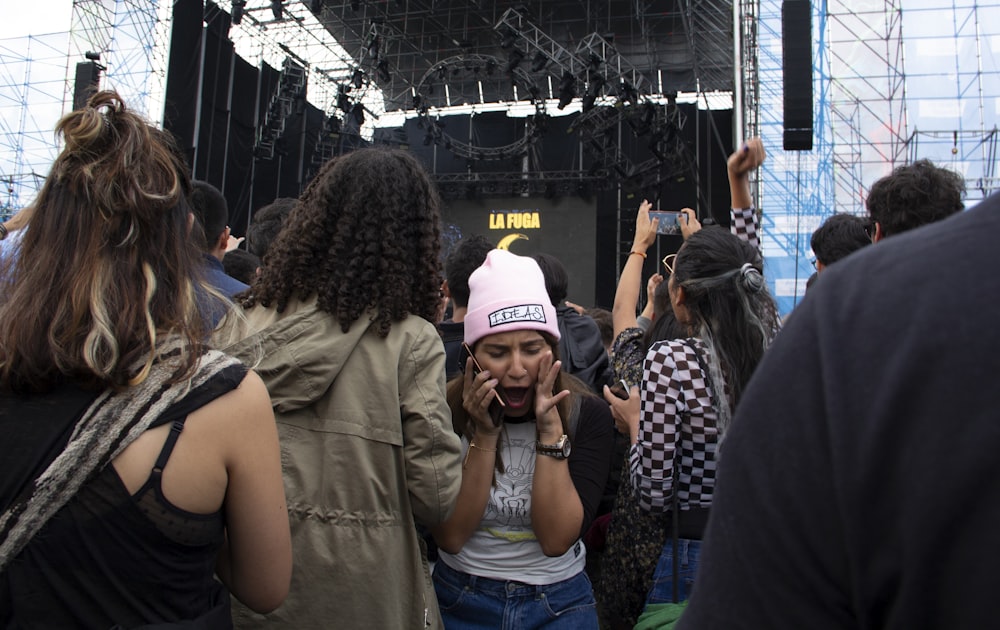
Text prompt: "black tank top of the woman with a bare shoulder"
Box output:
[[0, 366, 246, 630]]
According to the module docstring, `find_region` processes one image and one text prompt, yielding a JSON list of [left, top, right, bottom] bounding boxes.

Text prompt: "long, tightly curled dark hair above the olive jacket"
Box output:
[[241, 147, 441, 337]]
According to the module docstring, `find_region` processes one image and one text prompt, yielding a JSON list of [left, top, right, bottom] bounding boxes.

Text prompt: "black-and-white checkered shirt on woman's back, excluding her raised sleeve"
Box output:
[[629, 339, 719, 513]]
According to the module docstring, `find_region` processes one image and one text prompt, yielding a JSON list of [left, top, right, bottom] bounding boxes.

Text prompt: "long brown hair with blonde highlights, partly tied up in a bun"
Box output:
[[0, 91, 208, 392]]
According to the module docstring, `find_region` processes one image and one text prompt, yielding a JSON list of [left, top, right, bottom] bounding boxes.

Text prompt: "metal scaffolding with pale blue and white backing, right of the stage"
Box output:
[[752, 0, 1000, 313]]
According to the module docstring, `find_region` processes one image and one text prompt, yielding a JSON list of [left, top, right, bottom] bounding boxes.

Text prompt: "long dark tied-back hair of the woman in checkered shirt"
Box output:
[[673, 228, 780, 430]]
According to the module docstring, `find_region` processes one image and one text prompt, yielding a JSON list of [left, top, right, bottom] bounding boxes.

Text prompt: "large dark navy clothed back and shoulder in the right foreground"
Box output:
[[679, 195, 1000, 630]]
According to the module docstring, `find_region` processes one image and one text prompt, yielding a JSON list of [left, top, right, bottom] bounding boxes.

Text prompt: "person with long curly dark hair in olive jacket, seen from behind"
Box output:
[[216, 149, 461, 628]]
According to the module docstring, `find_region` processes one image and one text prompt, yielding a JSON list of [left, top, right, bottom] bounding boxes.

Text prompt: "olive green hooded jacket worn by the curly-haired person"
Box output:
[[214, 298, 462, 629]]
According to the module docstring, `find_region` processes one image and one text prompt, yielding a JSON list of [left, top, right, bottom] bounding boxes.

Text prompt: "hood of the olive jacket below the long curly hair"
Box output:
[[213, 296, 372, 413]]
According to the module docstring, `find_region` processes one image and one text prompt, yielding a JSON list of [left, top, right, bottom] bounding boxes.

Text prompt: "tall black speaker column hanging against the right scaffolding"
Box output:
[[781, 0, 813, 151]]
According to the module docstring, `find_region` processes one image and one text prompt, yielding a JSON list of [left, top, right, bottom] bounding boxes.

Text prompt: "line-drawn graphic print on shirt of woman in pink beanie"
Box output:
[[483, 432, 535, 541]]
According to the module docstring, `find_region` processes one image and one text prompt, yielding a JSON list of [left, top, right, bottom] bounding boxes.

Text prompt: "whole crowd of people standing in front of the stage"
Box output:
[[0, 91, 984, 630]]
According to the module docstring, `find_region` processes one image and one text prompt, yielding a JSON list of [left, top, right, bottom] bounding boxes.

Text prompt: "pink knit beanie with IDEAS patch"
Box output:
[[465, 249, 559, 346]]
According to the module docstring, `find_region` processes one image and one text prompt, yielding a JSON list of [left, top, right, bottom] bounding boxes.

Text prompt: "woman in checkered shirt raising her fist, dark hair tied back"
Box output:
[[605, 138, 780, 607]]
